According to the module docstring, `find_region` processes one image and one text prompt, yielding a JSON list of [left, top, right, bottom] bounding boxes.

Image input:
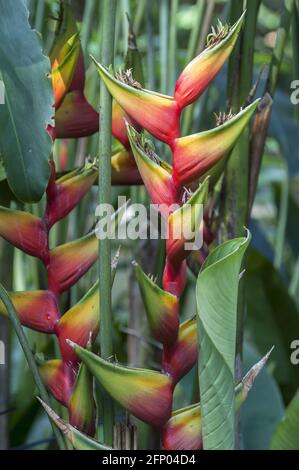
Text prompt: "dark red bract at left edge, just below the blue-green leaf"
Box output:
[[0, 206, 48, 261]]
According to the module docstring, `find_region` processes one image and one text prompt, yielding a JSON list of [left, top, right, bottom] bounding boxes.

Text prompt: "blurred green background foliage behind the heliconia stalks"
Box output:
[[0, 0, 299, 449]]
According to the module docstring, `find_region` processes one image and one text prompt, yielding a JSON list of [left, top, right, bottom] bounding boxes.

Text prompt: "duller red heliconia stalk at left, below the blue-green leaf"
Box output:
[[0, 162, 100, 435]]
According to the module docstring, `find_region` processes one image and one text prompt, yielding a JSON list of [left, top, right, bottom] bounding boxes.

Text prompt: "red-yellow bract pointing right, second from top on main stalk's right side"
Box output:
[[173, 100, 259, 186]]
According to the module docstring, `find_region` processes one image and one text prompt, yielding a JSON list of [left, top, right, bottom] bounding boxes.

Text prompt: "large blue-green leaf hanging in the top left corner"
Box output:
[[0, 0, 53, 202]]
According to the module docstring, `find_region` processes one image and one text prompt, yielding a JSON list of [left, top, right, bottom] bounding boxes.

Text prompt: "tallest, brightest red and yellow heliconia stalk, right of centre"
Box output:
[[54, 9, 258, 450]]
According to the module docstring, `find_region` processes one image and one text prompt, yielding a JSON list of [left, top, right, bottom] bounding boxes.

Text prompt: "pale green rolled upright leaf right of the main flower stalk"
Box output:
[[196, 234, 250, 450]]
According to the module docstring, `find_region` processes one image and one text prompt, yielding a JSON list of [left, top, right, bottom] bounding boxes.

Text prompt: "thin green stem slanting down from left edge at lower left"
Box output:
[[0, 283, 65, 450]]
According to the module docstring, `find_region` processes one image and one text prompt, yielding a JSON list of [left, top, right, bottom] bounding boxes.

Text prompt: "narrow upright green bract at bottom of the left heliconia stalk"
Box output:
[[68, 350, 96, 436]]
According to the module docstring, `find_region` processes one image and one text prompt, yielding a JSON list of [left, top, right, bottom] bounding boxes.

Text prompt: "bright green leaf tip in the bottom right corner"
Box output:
[[271, 389, 299, 450]]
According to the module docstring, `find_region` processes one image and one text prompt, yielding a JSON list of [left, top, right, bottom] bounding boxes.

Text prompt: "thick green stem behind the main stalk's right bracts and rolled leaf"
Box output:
[[225, 0, 260, 448]]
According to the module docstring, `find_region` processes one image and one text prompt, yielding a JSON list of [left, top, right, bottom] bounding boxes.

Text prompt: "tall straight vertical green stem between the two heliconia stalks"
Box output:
[[98, 0, 116, 445]]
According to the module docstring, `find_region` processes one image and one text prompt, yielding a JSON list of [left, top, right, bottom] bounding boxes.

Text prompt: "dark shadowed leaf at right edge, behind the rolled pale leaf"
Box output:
[[246, 250, 299, 402]]
